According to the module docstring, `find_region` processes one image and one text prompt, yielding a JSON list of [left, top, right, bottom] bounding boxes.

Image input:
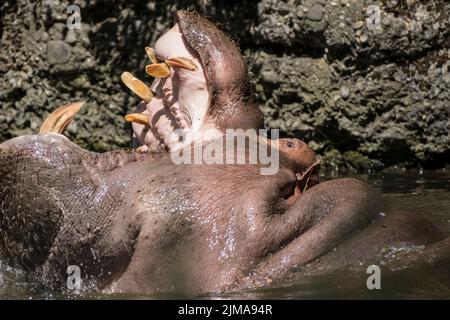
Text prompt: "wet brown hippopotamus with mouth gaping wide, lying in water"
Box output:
[[0, 11, 450, 294]]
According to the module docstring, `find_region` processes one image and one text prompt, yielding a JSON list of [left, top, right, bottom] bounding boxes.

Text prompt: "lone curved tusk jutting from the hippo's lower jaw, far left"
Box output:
[[39, 101, 84, 134]]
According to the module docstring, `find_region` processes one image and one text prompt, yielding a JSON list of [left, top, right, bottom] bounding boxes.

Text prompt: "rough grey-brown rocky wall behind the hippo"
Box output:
[[0, 0, 450, 170]]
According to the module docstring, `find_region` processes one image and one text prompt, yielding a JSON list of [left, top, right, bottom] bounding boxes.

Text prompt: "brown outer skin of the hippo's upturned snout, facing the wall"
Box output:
[[176, 10, 263, 129]]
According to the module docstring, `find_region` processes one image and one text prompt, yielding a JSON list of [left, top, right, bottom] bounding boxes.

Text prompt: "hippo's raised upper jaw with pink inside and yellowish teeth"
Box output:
[[122, 11, 262, 151]]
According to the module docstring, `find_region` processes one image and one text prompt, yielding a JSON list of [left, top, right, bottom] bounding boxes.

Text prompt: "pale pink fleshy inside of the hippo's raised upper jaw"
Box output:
[[133, 24, 216, 151]]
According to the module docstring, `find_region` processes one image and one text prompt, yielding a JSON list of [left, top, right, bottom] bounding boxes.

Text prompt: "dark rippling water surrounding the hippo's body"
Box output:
[[0, 170, 450, 299]]
